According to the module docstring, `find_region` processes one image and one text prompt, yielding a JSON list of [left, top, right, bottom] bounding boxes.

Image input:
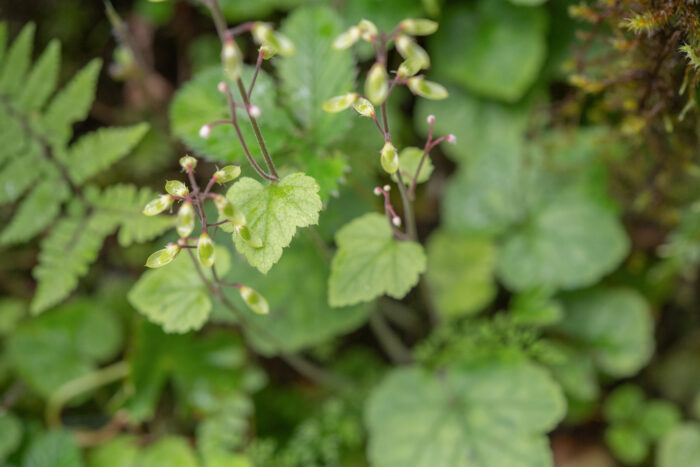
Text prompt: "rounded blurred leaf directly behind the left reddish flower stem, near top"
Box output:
[[170, 65, 292, 162]]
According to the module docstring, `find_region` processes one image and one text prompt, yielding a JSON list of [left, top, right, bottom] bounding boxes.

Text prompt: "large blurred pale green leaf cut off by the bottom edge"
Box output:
[[365, 362, 566, 467]]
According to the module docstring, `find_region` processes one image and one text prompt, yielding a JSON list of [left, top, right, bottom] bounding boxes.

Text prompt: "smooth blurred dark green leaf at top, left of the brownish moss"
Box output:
[[430, 0, 548, 102]]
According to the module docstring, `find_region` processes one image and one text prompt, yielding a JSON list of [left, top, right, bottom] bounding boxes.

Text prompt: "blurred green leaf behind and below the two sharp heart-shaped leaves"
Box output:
[[227, 235, 368, 355]]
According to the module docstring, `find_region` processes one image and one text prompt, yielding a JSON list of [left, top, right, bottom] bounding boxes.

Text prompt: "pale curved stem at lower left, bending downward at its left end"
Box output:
[[46, 361, 130, 428]]
